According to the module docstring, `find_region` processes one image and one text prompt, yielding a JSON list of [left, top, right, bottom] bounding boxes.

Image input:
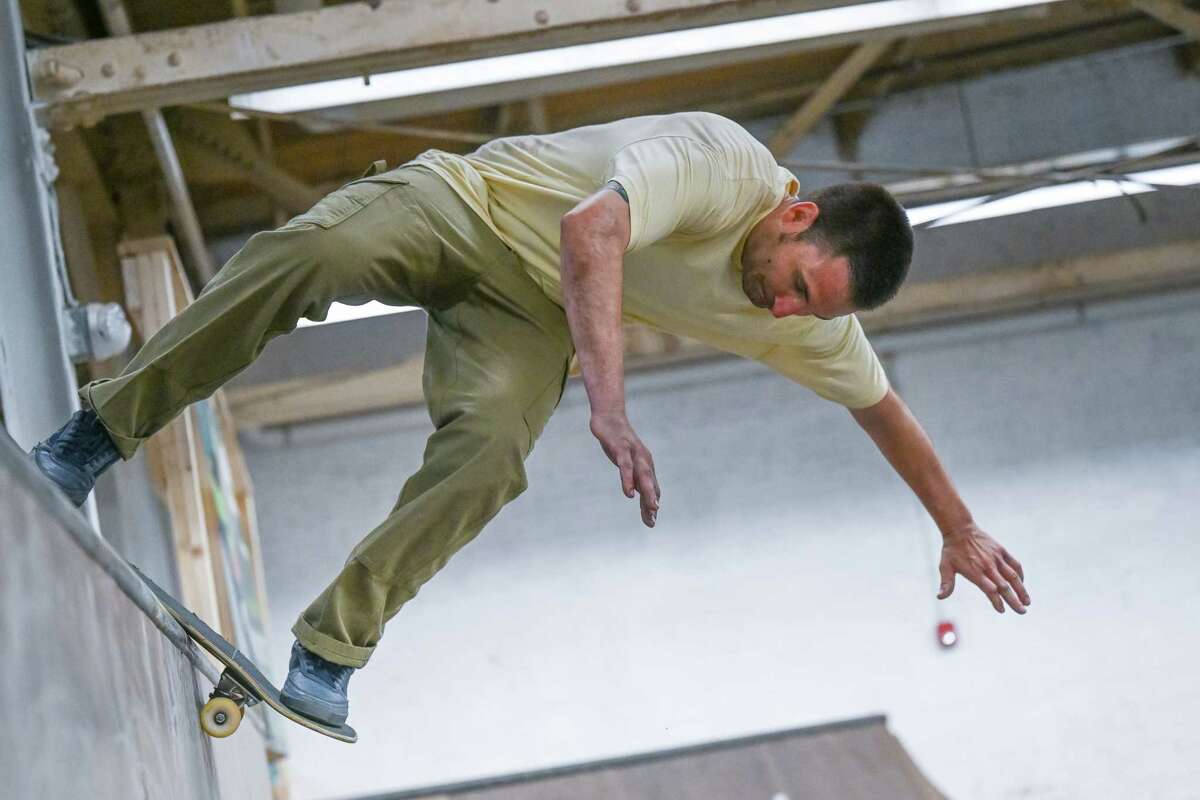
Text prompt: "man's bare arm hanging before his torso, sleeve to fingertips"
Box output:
[[560, 184, 662, 528]]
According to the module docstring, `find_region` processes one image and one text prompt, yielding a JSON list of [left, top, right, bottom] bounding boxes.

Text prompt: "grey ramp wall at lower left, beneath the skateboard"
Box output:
[[0, 434, 270, 800]]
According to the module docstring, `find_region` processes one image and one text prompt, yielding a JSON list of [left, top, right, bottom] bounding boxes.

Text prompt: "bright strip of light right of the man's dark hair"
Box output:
[[907, 163, 1200, 228]]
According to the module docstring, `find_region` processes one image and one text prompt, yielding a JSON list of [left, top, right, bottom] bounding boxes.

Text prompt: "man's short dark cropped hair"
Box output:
[[797, 184, 912, 309]]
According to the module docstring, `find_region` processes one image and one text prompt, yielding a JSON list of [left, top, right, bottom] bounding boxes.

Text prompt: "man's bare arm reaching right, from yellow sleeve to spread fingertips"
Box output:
[[850, 389, 1030, 614]]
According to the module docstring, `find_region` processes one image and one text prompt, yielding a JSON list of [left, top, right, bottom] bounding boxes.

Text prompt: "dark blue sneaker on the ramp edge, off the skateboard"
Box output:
[[30, 410, 121, 507]]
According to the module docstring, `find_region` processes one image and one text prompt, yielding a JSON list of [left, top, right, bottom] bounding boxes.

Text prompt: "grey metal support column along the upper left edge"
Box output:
[[0, 0, 79, 450]]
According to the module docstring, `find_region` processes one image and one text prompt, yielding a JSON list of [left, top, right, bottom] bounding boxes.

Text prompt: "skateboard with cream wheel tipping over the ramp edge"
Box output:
[[130, 564, 359, 744]]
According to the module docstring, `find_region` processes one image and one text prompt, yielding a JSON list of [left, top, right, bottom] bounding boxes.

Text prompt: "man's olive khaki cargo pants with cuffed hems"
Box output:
[[79, 166, 572, 667]]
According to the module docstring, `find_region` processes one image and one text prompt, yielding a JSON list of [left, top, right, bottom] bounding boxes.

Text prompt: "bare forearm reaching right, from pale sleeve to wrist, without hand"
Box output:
[[851, 390, 973, 535]]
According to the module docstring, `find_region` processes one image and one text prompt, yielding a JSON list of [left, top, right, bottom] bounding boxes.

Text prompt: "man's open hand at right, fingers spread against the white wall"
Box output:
[[937, 524, 1030, 614]]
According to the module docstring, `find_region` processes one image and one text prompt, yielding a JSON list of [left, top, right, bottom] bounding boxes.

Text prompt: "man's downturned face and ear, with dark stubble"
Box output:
[[742, 199, 854, 319]]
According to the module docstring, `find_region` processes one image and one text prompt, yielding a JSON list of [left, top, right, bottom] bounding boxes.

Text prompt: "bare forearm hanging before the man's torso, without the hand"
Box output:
[[560, 203, 625, 414]]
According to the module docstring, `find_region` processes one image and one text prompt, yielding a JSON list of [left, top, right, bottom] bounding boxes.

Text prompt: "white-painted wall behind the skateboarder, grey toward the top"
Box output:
[[244, 287, 1200, 800]]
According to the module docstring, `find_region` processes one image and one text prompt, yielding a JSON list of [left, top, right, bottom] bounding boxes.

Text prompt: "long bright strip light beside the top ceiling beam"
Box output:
[[229, 0, 1065, 114]]
